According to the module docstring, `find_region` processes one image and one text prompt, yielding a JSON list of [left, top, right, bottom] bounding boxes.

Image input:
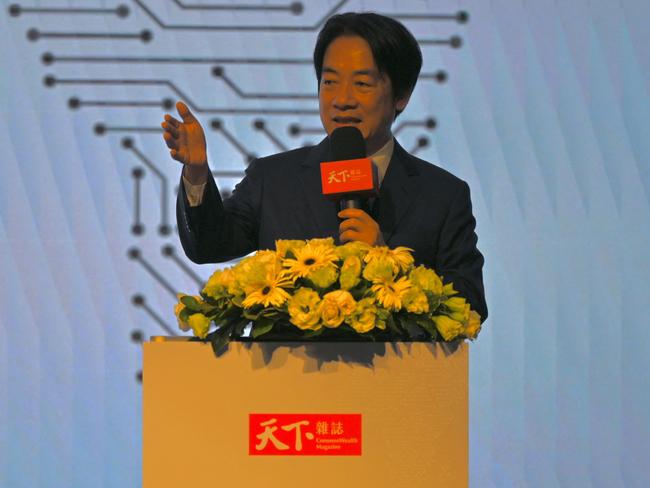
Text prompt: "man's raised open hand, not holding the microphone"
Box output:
[[160, 102, 209, 185]]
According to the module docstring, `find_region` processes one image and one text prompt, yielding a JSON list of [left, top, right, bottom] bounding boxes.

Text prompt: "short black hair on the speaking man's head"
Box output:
[[314, 12, 422, 115]]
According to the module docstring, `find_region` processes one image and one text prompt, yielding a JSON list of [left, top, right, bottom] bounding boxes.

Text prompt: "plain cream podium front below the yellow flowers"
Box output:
[[143, 341, 469, 488]]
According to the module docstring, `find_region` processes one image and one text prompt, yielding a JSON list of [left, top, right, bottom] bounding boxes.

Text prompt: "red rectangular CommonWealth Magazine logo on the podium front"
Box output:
[[248, 413, 361, 456]]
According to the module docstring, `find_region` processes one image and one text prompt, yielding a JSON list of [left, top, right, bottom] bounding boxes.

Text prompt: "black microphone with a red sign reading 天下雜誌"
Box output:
[[320, 125, 379, 210]]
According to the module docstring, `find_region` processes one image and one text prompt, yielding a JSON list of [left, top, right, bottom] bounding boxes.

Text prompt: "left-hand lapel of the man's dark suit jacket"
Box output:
[[299, 138, 339, 238]]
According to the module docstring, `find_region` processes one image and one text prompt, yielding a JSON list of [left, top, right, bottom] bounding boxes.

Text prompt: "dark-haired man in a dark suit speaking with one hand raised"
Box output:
[[162, 13, 487, 320]]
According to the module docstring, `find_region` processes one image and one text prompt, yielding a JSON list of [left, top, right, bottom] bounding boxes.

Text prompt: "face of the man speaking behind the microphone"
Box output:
[[318, 36, 408, 155]]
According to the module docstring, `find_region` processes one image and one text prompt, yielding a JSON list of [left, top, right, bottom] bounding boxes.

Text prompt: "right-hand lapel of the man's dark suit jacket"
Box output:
[[373, 141, 420, 244]]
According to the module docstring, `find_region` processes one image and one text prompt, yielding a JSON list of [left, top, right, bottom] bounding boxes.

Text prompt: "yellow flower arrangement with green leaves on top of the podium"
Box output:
[[175, 238, 481, 354]]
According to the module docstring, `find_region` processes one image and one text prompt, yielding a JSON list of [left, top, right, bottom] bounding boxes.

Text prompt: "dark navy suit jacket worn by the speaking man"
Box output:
[[176, 138, 487, 320]]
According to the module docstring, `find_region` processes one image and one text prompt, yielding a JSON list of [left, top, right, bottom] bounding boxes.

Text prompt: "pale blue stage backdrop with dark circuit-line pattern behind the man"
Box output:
[[0, 0, 650, 488]]
